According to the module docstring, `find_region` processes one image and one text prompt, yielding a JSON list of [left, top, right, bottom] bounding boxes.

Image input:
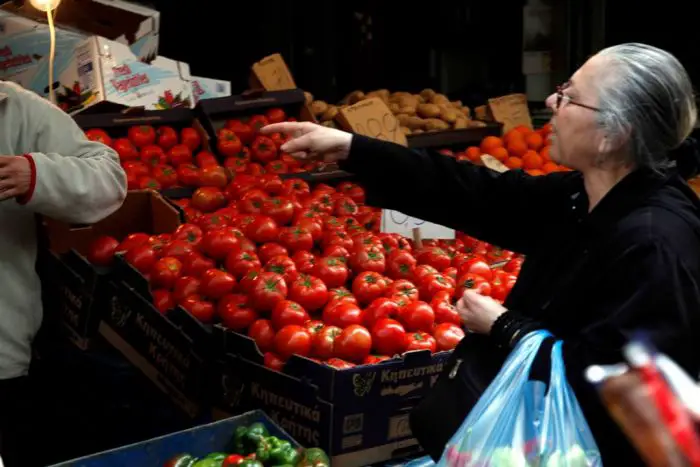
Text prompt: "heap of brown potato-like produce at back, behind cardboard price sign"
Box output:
[[307, 89, 485, 135]]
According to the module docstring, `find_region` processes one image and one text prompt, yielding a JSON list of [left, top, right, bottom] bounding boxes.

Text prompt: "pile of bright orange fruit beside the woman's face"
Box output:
[[455, 123, 571, 175]]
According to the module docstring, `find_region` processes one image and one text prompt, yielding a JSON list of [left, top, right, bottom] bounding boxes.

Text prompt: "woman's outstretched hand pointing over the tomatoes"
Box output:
[[260, 122, 352, 163]]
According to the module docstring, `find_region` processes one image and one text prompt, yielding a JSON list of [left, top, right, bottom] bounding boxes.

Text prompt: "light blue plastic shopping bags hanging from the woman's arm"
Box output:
[[438, 331, 601, 467]]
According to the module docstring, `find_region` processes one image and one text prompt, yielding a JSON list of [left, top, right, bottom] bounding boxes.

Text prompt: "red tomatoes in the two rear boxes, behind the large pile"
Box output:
[[85, 108, 318, 190]]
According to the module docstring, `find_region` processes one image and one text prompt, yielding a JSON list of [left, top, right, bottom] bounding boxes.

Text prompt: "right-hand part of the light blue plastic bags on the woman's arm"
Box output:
[[538, 341, 602, 467]]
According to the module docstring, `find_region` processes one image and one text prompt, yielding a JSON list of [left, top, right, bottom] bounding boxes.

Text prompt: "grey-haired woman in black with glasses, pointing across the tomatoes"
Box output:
[[265, 44, 700, 466]]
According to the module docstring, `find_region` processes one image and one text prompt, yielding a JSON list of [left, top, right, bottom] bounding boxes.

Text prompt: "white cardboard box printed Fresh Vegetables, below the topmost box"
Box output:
[[69, 36, 193, 114]]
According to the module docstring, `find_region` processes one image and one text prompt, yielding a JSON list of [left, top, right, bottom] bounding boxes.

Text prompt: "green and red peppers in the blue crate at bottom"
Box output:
[[164, 423, 330, 467]]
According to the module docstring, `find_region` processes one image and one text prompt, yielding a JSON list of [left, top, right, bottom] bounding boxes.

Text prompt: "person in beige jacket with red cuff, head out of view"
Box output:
[[0, 81, 127, 467]]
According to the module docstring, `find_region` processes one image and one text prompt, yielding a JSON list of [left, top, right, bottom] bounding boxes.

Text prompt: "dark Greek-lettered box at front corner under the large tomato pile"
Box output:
[[213, 326, 450, 467]]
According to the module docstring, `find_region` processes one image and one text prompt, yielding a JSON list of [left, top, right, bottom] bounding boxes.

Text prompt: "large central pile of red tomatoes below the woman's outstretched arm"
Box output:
[[89, 170, 521, 369]]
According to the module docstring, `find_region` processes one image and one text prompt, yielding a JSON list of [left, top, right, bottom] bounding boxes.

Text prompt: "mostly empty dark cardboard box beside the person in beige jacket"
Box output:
[[42, 191, 181, 350]]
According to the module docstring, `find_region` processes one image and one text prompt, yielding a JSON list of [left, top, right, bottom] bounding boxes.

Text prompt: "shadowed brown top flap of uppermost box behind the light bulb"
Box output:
[[0, 0, 152, 43]]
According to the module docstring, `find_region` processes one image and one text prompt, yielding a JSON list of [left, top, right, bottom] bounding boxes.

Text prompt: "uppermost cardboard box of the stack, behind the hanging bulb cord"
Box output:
[[0, 0, 160, 97]]
